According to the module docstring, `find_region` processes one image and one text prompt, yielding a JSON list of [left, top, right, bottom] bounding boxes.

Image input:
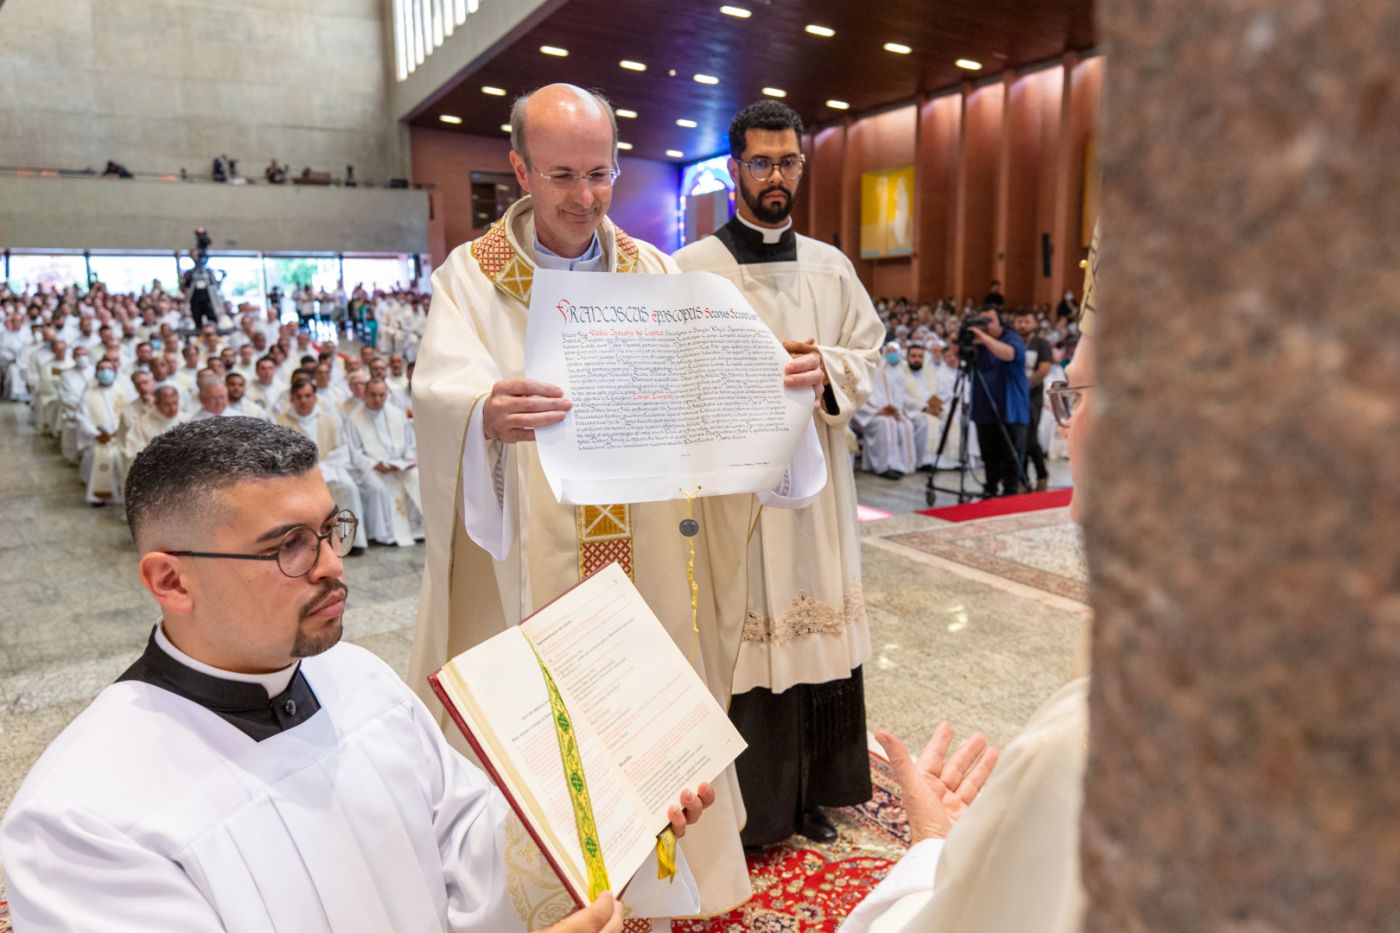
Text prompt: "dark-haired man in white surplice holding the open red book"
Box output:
[[0, 417, 714, 933]]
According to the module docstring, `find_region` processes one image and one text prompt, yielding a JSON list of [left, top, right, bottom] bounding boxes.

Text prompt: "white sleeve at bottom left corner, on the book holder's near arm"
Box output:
[[0, 808, 224, 933]]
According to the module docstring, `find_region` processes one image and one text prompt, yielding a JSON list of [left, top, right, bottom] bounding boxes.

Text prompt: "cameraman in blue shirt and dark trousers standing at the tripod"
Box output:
[[958, 308, 1030, 499]]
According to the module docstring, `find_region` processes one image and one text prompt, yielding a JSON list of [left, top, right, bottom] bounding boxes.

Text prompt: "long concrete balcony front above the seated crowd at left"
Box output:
[[0, 175, 428, 252]]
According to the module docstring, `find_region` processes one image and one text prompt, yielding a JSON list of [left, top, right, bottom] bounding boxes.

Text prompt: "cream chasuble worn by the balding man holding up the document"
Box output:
[[409, 196, 750, 927]]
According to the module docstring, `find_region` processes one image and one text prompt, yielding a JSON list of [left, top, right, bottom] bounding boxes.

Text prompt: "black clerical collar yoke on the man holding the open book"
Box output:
[[116, 632, 321, 742]]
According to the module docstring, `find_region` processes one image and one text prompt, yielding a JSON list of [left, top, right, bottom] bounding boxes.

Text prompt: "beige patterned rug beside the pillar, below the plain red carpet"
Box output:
[[888, 509, 1089, 602]]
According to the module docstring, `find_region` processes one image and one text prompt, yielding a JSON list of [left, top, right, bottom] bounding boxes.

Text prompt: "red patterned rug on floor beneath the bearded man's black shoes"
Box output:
[[672, 755, 909, 933]]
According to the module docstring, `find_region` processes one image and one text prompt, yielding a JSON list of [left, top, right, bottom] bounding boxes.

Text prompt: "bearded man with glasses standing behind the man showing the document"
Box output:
[[675, 101, 885, 848]]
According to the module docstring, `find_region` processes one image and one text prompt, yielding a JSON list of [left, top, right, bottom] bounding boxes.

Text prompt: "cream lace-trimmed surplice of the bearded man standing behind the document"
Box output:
[[675, 225, 885, 693]]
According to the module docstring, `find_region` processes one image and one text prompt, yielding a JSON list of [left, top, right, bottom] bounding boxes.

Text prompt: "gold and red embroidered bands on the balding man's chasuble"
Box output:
[[472, 217, 640, 580]]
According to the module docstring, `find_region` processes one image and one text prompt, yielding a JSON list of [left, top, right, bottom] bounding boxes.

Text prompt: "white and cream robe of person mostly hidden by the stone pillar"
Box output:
[[840, 677, 1089, 933]]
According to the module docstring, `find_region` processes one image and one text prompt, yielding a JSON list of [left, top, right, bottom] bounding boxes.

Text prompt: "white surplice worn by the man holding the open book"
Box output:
[[0, 644, 522, 933]]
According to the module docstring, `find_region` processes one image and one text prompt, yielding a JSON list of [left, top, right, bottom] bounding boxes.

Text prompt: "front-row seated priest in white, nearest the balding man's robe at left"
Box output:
[[346, 380, 423, 548]]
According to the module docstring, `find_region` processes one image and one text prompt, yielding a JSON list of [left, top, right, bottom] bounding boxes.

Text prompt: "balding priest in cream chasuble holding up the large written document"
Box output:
[[409, 84, 820, 919]]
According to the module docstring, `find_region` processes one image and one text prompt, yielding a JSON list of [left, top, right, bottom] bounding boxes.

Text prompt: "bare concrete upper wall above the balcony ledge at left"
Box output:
[[0, 0, 407, 183]]
